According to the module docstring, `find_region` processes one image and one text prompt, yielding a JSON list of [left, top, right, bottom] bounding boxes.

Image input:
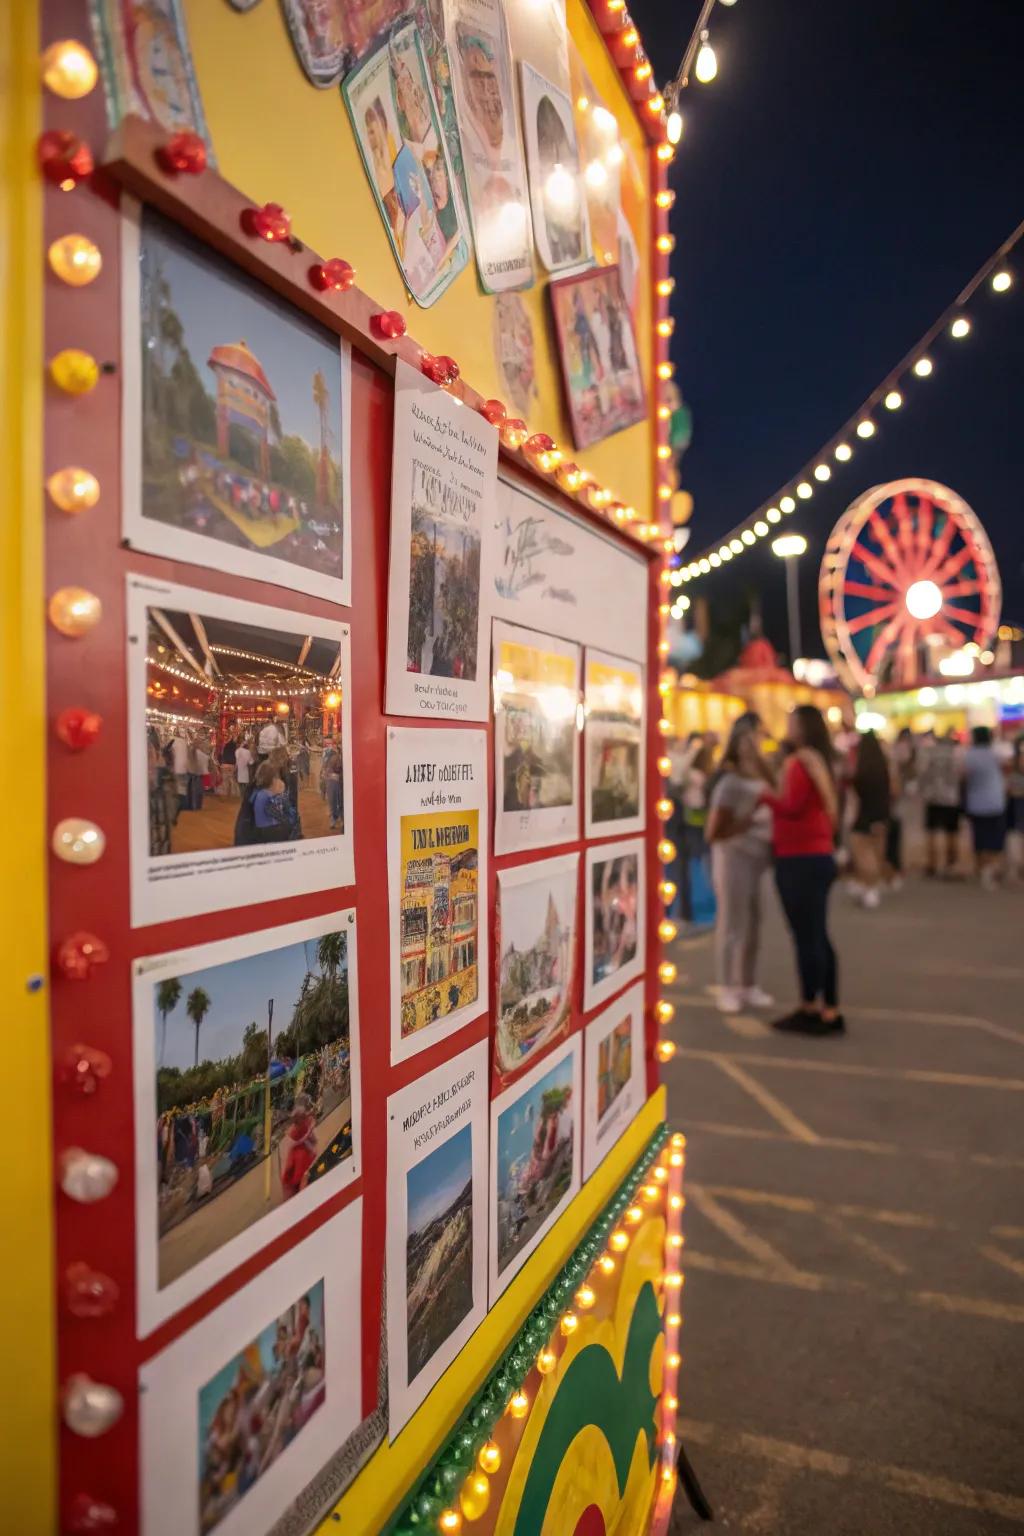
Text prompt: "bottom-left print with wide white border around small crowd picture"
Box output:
[[138, 1200, 362, 1536]]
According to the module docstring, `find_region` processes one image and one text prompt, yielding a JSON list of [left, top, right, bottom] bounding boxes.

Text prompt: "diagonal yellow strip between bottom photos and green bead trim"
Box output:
[[318, 1087, 666, 1536]]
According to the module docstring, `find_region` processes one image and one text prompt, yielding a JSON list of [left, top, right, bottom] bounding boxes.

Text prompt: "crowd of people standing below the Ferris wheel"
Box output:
[[669, 703, 1024, 1035]]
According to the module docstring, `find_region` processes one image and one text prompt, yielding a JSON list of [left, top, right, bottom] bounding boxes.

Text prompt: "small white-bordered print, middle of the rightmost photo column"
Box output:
[[583, 837, 646, 1012]]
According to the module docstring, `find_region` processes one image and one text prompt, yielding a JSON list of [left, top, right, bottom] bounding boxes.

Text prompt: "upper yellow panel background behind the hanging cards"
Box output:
[[186, 0, 654, 511]]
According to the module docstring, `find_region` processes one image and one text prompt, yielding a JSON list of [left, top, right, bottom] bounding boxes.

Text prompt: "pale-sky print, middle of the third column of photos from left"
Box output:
[[494, 854, 579, 1087]]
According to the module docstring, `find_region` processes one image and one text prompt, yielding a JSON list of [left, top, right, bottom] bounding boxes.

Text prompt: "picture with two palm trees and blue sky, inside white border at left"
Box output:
[[150, 932, 352, 1287]]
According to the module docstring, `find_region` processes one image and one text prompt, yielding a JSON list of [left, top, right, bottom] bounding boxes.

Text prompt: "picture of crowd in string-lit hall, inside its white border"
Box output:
[[146, 607, 345, 866]]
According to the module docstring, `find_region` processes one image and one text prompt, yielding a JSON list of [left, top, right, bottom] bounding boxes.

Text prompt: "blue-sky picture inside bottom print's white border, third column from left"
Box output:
[[496, 1054, 576, 1275]]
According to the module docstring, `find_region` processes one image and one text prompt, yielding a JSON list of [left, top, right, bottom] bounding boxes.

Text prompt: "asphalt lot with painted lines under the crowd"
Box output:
[[666, 880, 1024, 1536]]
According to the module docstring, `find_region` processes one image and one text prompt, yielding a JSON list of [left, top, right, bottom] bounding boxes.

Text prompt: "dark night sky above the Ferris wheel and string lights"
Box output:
[[631, 0, 1024, 654]]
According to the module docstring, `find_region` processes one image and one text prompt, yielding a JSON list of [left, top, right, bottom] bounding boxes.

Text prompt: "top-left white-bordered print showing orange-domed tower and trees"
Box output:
[[121, 198, 352, 605]]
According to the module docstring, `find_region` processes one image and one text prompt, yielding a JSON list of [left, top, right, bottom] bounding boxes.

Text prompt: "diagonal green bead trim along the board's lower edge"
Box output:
[[385, 1124, 668, 1536]]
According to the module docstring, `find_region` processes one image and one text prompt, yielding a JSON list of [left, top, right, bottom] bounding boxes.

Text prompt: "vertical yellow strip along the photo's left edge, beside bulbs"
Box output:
[[0, 0, 57, 1536]]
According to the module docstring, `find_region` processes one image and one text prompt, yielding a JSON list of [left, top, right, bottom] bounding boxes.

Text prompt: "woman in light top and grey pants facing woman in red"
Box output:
[[705, 714, 772, 1014]]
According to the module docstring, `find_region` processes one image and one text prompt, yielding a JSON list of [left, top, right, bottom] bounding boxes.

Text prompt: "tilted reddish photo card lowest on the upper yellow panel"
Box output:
[[550, 267, 646, 449]]
